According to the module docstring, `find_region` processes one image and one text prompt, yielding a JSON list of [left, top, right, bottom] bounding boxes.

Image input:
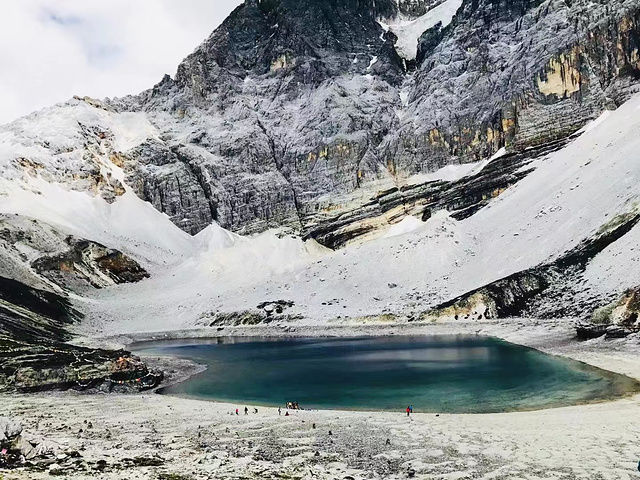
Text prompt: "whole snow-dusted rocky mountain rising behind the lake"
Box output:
[[0, 0, 640, 388]]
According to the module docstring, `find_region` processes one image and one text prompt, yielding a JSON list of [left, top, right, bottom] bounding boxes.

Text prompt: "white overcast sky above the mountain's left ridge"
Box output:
[[0, 0, 242, 124]]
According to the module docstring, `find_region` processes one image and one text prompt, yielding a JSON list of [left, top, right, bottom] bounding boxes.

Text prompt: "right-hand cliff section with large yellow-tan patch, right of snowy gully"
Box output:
[[400, 0, 639, 169]]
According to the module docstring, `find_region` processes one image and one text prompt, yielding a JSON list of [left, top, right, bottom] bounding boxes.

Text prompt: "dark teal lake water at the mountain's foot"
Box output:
[[134, 336, 639, 413]]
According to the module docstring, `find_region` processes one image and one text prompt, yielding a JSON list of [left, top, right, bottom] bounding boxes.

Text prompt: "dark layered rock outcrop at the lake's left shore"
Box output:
[[0, 277, 162, 391]]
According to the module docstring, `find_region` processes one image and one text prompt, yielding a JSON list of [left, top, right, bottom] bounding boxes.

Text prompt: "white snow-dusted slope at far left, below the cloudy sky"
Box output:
[[0, 100, 197, 278]]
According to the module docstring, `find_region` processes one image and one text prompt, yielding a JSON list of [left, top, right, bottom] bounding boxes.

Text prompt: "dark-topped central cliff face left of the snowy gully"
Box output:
[[119, 1, 404, 233]]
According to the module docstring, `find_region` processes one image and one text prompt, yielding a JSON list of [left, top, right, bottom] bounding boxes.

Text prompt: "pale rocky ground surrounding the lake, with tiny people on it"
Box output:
[[0, 320, 640, 479]]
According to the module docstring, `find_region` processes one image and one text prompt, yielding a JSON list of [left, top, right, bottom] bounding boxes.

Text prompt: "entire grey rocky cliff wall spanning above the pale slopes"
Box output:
[[3, 0, 640, 243]]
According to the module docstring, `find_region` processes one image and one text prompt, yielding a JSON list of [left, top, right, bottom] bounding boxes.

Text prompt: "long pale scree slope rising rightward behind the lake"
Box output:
[[76, 97, 640, 332]]
